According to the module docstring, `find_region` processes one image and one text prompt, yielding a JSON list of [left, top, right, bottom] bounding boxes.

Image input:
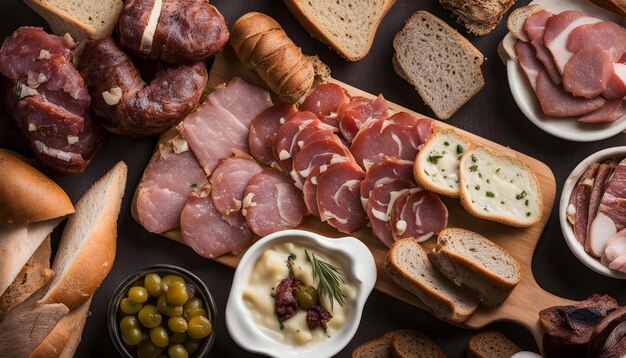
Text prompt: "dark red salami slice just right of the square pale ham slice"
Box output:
[[248, 105, 296, 166]]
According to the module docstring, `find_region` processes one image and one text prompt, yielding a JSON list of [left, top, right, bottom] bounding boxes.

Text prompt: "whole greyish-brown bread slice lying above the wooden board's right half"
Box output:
[[393, 10, 485, 119]]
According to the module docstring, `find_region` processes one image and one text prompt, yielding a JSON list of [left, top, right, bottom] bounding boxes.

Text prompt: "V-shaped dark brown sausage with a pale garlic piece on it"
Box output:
[[80, 37, 208, 137]]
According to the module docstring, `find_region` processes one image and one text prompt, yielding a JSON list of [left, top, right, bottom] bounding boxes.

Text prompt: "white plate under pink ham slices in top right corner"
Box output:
[[506, 0, 626, 142]]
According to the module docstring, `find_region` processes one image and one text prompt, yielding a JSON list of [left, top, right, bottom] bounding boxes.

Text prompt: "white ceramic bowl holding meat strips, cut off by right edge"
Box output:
[[559, 146, 626, 279]]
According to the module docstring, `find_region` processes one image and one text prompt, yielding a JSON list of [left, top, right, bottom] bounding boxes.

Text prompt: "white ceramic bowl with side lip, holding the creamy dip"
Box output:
[[226, 230, 376, 358]]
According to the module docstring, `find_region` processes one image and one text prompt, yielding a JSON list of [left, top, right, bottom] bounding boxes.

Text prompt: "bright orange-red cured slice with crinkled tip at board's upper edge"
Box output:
[[337, 94, 389, 143]]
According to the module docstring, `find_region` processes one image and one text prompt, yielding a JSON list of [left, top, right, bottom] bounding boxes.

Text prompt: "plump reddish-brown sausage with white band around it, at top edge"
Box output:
[[117, 0, 229, 64]]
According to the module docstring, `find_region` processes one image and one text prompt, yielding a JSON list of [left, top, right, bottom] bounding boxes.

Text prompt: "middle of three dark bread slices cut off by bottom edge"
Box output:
[[391, 330, 446, 358]]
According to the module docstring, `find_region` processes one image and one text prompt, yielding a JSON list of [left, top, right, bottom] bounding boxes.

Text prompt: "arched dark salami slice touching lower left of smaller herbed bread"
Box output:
[[361, 156, 415, 208]]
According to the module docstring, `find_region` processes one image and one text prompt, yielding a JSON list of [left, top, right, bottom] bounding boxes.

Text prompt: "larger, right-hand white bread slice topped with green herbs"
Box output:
[[461, 146, 543, 227]]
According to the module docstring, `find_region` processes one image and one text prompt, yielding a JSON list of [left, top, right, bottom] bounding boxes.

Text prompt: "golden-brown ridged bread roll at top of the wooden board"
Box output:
[[230, 12, 315, 103]]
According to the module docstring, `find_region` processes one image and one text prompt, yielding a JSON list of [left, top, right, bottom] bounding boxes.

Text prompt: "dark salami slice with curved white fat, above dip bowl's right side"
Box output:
[[317, 162, 367, 233]]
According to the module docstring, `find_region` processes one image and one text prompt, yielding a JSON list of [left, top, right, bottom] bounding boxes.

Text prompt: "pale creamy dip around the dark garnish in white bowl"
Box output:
[[242, 243, 356, 346]]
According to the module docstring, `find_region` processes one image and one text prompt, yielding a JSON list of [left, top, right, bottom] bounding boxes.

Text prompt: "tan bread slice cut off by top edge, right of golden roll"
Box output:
[[284, 0, 396, 61]]
